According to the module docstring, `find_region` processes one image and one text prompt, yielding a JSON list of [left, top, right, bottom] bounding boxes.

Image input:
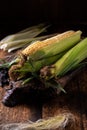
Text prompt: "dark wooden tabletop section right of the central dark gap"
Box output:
[[43, 69, 87, 130]]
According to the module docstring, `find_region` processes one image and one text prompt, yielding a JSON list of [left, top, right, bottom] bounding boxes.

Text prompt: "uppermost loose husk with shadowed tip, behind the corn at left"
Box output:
[[0, 24, 46, 45]]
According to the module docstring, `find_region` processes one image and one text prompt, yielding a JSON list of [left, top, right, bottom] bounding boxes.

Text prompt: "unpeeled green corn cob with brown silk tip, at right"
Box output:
[[41, 38, 87, 79]]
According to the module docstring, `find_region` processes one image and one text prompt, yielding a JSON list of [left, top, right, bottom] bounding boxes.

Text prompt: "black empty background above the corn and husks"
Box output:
[[0, 0, 87, 38]]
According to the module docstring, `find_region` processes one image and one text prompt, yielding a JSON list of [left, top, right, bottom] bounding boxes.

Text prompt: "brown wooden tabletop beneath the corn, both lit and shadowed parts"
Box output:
[[0, 51, 87, 130]]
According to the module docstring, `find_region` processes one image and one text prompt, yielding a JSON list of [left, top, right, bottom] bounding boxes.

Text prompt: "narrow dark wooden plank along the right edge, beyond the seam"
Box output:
[[78, 69, 87, 130]]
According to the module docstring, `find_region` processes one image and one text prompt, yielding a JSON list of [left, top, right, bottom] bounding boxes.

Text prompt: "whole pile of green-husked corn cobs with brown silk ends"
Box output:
[[0, 26, 87, 90]]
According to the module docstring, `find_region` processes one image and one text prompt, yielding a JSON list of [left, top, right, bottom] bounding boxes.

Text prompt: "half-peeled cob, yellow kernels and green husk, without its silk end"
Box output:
[[22, 31, 82, 60]]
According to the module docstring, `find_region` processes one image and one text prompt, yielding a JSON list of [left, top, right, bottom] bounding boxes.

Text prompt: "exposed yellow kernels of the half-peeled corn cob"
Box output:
[[22, 31, 75, 56]]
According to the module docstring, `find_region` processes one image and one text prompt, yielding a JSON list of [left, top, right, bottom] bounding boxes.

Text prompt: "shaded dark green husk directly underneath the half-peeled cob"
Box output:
[[9, 52, 65, 79]]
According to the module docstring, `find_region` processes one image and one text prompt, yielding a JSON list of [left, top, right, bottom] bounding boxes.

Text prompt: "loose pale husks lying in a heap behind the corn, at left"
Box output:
[[0, 24, 48, 52]]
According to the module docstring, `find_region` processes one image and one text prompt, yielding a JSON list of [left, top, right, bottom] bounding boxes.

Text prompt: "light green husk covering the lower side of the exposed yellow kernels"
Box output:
[[29, 31, 82, 60]]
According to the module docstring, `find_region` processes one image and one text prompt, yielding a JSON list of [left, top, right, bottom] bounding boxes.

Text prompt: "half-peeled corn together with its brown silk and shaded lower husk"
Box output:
[[9, 31, 81, 80]]
